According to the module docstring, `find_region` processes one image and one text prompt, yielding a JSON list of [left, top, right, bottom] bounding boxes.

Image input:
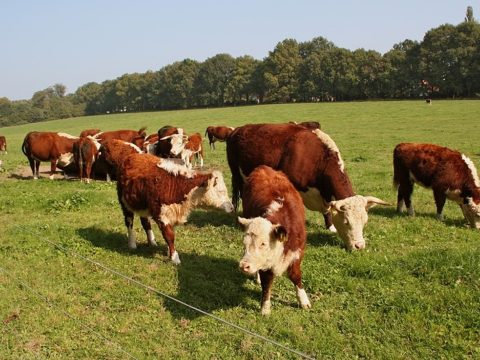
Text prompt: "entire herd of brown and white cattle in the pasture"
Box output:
[[0, 122, 480, 314]]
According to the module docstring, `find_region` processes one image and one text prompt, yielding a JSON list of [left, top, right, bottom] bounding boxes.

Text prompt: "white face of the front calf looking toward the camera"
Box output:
[[238, 217, 287, 275]]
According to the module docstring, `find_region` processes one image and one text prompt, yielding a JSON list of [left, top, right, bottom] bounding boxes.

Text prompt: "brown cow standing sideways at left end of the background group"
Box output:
[[22, 131, 79, 179]]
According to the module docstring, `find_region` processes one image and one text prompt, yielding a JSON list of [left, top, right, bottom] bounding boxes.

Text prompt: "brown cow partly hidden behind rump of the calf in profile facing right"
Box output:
[[95, 139, 142, 181]]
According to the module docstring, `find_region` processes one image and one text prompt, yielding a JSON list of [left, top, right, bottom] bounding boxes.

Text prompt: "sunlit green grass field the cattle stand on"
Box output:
[[0, 101, 480, 359]]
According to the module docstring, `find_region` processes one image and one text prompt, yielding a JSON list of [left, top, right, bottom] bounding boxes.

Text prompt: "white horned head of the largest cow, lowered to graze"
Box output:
[[328, 195, 390, 250]]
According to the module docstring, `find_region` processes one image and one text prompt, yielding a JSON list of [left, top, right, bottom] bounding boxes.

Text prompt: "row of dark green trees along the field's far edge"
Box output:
[[0, 7, 480, 126]]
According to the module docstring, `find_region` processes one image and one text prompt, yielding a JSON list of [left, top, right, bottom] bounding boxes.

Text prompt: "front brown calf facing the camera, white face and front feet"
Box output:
[[238, 165, 311, 315]]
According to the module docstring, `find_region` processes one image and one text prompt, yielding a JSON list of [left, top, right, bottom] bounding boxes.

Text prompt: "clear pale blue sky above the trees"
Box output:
[[0, 0, 480, 100]]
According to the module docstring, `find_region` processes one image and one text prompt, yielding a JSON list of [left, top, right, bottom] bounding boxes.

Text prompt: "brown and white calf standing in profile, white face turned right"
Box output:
[[117, 154, 233, 265]]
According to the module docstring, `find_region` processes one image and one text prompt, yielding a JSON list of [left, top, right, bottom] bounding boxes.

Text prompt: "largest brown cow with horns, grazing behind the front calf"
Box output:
[[227, 124, 389, 250]]
